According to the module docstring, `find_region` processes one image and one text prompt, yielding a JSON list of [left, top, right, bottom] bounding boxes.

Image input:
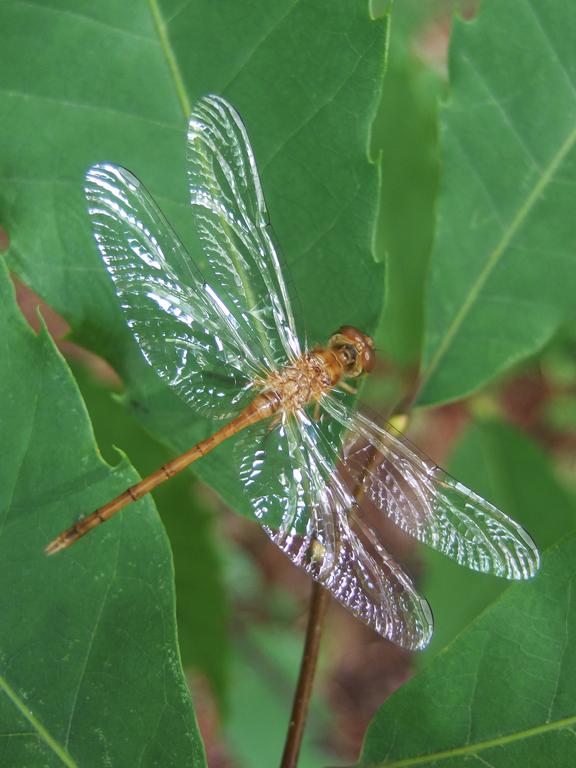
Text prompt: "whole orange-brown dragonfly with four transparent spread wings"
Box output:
[[46, 95, 539, 649]]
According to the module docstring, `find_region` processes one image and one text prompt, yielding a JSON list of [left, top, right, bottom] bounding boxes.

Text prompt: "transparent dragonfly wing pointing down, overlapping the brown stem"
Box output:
[[236, 412, 432, 649]]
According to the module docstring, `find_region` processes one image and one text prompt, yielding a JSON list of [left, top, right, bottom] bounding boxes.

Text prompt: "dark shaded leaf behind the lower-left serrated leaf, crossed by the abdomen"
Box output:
[[74, 366, 230, 709]]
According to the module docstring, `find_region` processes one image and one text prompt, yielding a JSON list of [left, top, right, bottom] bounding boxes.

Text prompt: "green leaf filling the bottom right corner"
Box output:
[[359, 534, 576, 768]]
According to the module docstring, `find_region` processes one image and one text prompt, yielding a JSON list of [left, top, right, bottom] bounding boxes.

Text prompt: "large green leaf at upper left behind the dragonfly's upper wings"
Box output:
[[0, 0, 386, 512]]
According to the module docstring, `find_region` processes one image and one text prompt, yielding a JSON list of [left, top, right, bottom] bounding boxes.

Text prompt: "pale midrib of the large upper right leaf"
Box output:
[[419, 121, 576, 392]]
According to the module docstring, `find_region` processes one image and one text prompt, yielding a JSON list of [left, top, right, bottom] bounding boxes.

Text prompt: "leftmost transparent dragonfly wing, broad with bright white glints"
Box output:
[[85, 164, 262, 418]]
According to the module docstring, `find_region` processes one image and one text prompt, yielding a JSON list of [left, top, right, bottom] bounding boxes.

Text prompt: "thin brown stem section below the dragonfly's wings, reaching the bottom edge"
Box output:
[[280, 581, 328, 768]]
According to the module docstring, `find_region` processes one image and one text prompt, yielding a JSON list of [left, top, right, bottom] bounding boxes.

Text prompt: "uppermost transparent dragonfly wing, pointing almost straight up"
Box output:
[[187, 96, 300, 369]]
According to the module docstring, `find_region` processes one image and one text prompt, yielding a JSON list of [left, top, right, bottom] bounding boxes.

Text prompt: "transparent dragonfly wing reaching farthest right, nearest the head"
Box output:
[[322, 395, 540, 579]]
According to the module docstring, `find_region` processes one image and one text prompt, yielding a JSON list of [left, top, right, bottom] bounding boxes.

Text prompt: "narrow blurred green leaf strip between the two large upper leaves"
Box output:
[[372, 2, 443, 366]]
